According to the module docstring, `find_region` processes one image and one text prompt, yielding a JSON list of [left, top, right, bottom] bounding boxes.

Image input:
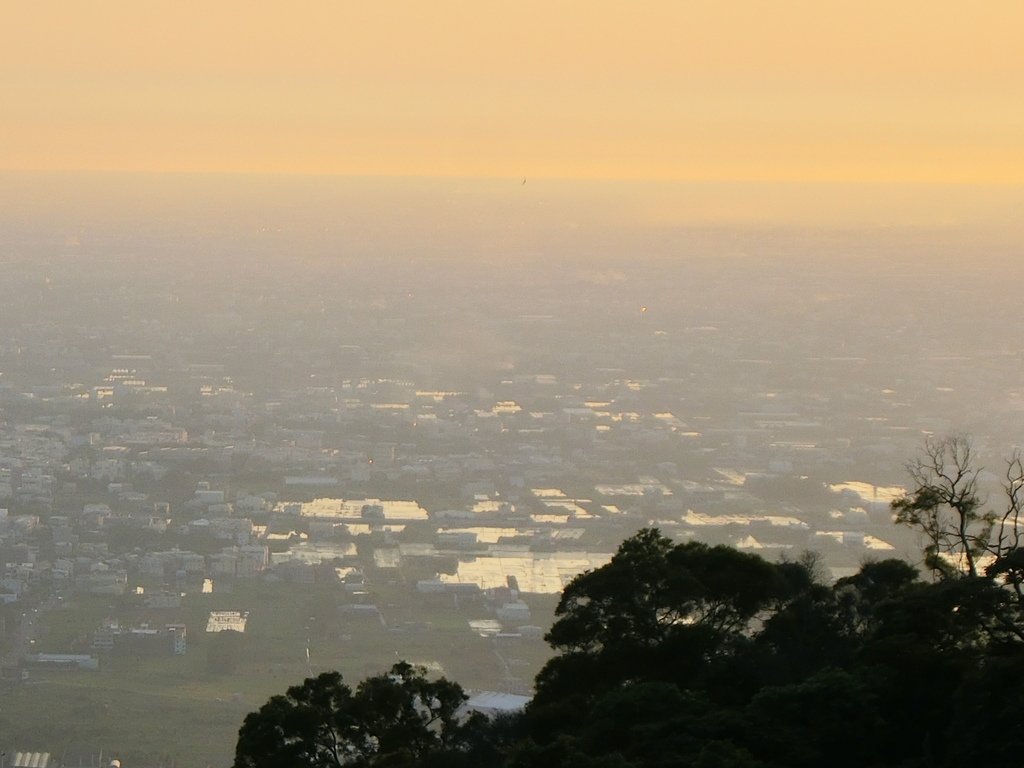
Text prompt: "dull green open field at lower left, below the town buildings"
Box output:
[[0, 571, 554, 768]]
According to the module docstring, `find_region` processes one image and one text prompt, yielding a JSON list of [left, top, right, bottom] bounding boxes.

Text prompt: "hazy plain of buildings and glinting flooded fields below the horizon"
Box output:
[[0, 188, 1024, 766]]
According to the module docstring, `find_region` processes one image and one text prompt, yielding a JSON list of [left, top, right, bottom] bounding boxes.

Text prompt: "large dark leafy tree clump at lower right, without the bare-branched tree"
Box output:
[[513, 528, 1024, 768]]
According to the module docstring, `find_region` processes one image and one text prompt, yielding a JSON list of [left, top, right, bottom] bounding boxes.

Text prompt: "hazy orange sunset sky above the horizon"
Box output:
[[0, 0, 1024, 184]]
